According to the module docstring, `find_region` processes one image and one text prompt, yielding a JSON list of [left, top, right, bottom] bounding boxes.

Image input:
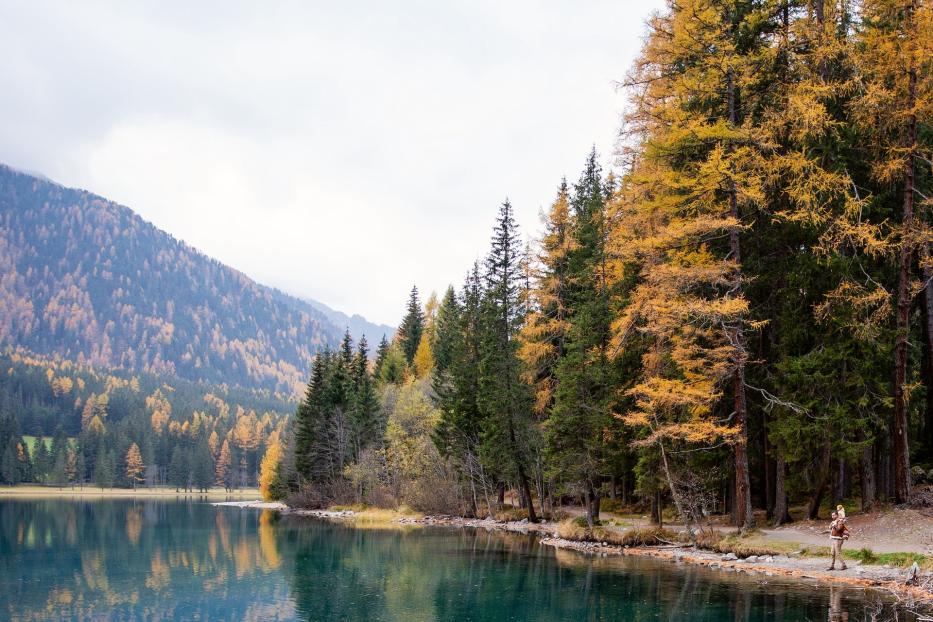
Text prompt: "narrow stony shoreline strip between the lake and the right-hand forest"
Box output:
[[220, 501, 933, 607]]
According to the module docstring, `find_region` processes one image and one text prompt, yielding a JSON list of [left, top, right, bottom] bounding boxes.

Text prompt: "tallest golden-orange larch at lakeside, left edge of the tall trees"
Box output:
[[614, 0, 763, 526]]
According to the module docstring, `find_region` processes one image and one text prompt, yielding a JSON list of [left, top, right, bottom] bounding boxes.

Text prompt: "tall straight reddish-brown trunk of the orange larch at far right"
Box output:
[[893, 50, 917, 503]]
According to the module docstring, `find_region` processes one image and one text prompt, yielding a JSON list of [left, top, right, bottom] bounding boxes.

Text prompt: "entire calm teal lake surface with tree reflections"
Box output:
[[0, 499, 911, 622]]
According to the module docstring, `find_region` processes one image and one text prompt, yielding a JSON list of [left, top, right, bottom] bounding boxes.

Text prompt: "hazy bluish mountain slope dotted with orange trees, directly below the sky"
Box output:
[[0, 165, 343, 393]]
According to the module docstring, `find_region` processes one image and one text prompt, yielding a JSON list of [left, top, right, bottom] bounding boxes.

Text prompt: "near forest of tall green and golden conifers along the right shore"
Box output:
[[277, 0, 933, 527]]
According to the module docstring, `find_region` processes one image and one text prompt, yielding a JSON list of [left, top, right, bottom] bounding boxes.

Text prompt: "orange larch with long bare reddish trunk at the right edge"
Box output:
[[850, 0, 933, 502]]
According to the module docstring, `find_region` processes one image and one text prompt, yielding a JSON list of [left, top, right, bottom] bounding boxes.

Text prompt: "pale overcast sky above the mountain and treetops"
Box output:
[[0, 0, 663, 324]]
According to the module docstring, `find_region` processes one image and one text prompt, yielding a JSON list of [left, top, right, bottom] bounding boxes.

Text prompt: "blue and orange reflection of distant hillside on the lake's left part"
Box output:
[[0, 499, 295, 620]]
